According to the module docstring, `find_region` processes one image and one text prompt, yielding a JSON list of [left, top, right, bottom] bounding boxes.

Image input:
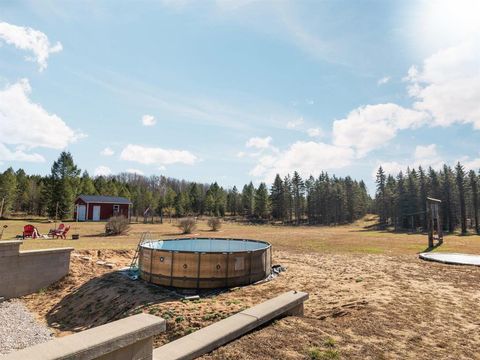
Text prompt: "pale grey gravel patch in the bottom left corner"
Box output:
[[0, 300, 52, 354]]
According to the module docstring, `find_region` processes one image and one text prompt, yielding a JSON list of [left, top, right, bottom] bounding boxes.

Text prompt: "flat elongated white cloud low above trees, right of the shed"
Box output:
[[120, 144, 197, 166]]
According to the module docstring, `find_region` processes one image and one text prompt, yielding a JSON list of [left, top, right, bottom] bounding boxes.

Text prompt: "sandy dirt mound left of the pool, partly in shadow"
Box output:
[[24, 250, 176, 336]]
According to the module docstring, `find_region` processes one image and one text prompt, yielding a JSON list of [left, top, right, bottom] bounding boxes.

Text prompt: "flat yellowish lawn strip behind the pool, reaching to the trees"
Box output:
[[0, 217, 480, 255]]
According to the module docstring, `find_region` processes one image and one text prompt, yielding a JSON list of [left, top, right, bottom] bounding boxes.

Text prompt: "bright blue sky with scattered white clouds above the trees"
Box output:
[[0, 0, 480, 193]]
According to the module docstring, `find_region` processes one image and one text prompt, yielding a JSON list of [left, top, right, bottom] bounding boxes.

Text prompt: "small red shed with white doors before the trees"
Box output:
[[73, 195, 132, 221]]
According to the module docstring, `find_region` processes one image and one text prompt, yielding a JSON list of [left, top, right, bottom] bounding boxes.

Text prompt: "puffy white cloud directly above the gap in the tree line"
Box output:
[[333, 103, 428, 157]]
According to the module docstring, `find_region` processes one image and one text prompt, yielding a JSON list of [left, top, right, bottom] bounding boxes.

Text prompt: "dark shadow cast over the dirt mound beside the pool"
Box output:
[[46, 272, 178, 331]]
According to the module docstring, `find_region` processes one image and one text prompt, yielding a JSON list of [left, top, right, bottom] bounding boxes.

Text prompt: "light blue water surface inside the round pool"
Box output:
[[142, 238, 270, 252]]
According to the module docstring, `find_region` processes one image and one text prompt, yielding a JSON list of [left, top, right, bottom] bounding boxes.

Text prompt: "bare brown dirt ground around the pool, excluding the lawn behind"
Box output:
[[25, 250, 480, 359]]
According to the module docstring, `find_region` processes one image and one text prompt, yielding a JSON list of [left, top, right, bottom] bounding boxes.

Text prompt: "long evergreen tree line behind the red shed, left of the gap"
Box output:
[[0, 152, 372, 225]]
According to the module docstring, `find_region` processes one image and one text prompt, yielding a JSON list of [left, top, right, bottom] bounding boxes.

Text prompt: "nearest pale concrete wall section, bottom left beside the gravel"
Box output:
[[0, 314, 166, 360]]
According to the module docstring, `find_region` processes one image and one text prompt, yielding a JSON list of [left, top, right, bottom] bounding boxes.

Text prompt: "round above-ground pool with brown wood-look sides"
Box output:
[[138, 238, 272, 289]]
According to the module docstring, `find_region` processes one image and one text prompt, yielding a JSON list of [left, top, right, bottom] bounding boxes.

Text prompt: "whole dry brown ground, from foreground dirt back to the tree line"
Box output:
[[6, 215, 480, 360]]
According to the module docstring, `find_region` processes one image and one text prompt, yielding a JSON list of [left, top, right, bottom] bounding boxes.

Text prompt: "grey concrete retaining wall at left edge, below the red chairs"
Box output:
[[0, 240, 73, 299]]
